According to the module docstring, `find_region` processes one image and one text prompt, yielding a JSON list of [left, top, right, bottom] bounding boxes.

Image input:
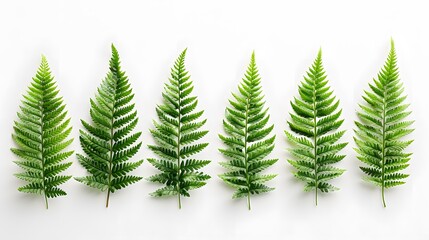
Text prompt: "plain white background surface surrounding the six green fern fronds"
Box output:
[[0, 0, 429, 240]]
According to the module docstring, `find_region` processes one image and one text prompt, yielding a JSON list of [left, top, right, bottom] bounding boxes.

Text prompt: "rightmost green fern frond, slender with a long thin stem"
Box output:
[[355, 41, 414, 207]]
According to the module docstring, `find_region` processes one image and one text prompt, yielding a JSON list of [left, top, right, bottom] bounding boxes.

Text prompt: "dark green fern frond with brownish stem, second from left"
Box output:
[[76, 45, 143, 207]]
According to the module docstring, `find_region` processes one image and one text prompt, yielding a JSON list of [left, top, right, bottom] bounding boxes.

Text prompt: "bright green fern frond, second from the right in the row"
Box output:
[[285, 50, 347, 205]]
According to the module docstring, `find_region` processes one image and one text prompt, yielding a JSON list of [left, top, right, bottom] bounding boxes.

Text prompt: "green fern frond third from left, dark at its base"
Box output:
[[148, 49, 210, 208]]
